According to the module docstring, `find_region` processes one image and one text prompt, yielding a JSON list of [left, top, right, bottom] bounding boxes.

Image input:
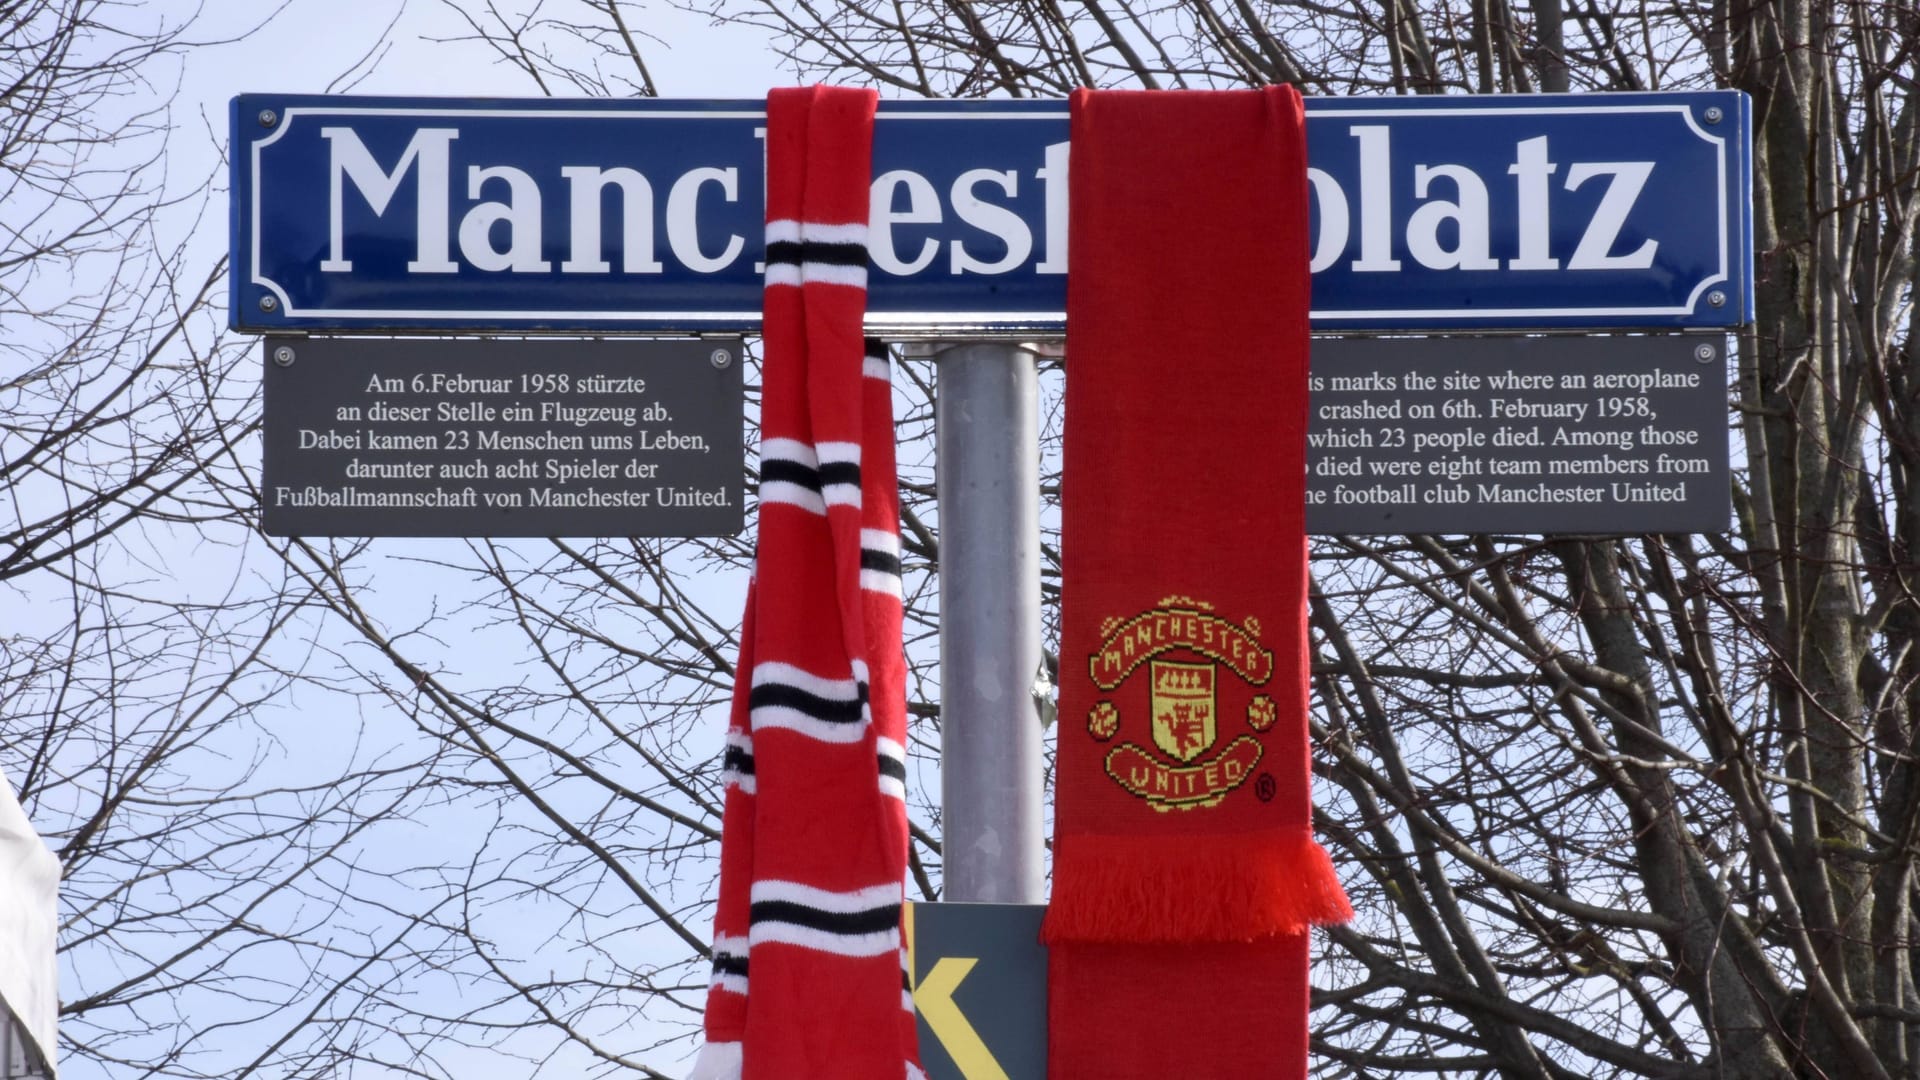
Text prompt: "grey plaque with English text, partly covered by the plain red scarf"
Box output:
[[1308, 334, 1732, 534]]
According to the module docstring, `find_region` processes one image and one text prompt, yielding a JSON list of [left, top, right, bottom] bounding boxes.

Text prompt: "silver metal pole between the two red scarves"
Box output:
[[933, 344, 1046, 903]]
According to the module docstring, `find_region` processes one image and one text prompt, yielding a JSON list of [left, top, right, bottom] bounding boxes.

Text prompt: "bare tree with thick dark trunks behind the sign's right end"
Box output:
[[716, 0, 1920, 1078]]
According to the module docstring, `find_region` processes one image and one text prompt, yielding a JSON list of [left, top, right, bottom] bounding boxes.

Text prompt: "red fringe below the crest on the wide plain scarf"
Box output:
[[1041, 826, 1354, 945]]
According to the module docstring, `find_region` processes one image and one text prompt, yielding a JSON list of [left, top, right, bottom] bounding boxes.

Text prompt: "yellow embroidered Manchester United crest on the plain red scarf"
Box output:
[[1087, 596, 1277, 813]]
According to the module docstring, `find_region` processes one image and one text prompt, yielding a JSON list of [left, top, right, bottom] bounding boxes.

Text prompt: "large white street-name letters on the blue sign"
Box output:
[[319, 123, 1659, 277]]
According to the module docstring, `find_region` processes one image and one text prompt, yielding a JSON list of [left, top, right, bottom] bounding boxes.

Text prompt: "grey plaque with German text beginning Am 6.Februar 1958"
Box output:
[[261, 338, 745, 536]]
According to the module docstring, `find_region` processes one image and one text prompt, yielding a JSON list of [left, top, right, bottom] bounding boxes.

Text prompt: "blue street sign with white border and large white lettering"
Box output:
[[232, 90, 1753, 338]]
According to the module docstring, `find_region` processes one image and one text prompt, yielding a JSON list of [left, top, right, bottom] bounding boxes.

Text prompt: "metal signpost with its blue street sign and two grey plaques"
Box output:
[[230, 92, 1753, 1080]]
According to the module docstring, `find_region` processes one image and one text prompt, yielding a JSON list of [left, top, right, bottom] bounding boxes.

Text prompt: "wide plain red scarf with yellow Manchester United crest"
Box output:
[[1043, 88, 1352, 1080]]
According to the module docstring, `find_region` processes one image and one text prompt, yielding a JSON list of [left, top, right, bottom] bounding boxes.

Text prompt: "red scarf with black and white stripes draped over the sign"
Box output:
[[693, 88, 920, 1080]]
